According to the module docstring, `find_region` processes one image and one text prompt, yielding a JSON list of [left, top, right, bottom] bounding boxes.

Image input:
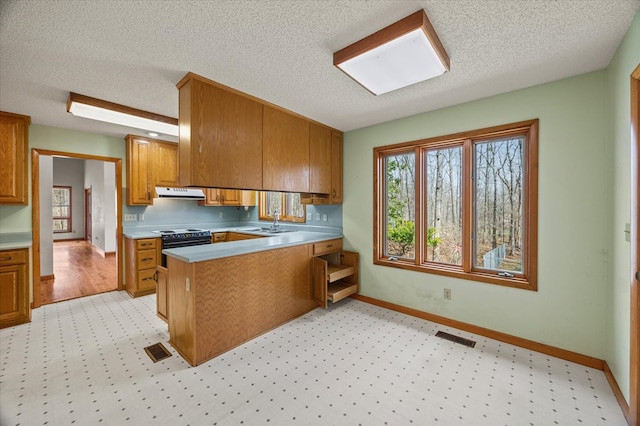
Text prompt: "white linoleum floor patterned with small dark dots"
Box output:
[[0, 292, 626, 426]]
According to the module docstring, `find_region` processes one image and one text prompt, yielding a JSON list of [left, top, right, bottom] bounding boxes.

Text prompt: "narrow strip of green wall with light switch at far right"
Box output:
[[605, 9, 640, 401]]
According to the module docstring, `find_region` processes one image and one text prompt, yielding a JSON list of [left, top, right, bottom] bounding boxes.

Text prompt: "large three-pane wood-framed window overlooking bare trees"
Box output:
[[374, 120, 538, 290]]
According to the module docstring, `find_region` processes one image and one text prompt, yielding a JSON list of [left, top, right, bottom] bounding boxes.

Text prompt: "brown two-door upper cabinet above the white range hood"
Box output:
[[125, 135, 179, 206]]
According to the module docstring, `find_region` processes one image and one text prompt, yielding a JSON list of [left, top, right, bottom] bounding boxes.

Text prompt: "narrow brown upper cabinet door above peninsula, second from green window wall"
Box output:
[[309, 123, 332, 194]]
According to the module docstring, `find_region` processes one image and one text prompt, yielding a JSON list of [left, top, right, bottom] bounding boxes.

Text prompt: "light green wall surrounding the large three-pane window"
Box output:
[[343, 71, 612, 358]]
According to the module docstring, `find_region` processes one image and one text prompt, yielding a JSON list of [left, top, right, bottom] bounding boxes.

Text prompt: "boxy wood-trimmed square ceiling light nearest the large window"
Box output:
[[333, 10, 449, 95]]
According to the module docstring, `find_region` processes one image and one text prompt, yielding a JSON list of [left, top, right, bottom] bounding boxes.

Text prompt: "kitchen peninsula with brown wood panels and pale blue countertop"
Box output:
[[151, 230, 357, 366]]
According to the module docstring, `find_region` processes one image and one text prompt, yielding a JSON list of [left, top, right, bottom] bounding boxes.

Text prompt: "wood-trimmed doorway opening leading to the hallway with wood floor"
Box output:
[[31, 148, 123, 308]]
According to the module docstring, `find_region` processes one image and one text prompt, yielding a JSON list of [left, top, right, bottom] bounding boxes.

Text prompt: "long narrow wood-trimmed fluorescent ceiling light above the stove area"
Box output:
[[67, 92, 178, 136]]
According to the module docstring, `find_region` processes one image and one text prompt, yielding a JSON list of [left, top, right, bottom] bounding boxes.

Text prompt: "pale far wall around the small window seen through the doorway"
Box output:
[[52, 157, 84, 241]]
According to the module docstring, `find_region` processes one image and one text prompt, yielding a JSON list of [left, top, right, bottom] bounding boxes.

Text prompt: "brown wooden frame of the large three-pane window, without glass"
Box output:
[[373, 119, 539, 291]]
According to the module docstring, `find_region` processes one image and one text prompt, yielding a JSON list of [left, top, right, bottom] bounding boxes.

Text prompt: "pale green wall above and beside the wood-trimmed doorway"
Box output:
[[0, 124, 126, 233]]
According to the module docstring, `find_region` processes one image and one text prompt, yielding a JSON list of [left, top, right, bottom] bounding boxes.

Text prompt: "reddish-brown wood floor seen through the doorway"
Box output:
[[40, 241, 118, 305]]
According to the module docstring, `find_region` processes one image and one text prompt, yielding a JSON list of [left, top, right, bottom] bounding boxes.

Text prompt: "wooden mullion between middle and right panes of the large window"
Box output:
[[462, 139, 475, 272]]
